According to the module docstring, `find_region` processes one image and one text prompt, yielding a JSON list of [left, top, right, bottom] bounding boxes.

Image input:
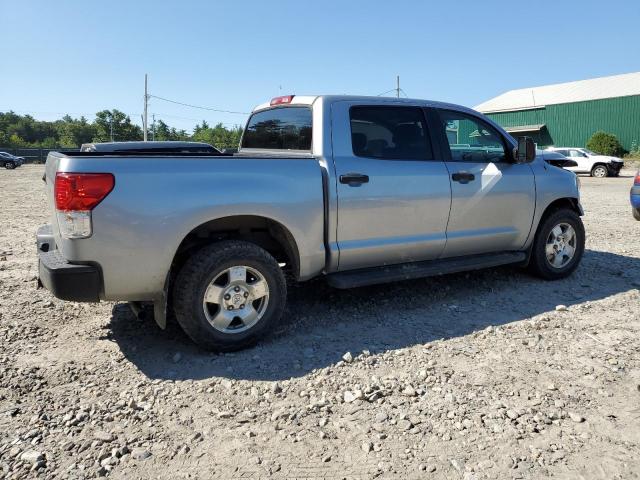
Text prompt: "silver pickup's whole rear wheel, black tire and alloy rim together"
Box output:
[[173, 241, 287, 351]]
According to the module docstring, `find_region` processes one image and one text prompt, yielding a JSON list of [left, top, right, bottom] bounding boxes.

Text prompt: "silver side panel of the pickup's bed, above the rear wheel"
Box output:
[[45, 152, 325, 300]]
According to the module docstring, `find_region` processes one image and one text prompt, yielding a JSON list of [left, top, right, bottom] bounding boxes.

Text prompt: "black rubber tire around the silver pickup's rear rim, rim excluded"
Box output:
[[173, 240, 287, 352]]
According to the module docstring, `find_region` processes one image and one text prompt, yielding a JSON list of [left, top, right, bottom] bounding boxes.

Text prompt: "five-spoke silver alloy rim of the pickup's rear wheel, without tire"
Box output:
[[202, 266, 269, 333]]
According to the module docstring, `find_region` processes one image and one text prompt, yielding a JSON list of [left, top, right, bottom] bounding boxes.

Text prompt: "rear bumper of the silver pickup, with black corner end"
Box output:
[[37, 225, 102, 302]]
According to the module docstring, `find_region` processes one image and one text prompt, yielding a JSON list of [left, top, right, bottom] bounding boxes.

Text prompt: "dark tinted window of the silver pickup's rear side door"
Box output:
[[349, 106, 433, 160]]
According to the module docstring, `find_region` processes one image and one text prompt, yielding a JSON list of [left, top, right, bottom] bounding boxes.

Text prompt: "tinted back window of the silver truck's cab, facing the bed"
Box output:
[[242, 107, 311, 150]]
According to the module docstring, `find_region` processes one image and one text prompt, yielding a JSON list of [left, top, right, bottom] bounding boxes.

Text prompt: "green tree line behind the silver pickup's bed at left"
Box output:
[[0, 109, 242, 148]]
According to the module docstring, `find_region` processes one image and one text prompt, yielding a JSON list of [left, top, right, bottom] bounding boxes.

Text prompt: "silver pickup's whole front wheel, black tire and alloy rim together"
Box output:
[[529, 209, 585, 280]]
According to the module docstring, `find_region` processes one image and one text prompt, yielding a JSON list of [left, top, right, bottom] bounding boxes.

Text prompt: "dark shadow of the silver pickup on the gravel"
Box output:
[[109, 250, 640, 380]]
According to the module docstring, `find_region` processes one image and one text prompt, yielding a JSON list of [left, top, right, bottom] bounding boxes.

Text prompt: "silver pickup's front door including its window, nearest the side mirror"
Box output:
[[432, 109, 536, 257]]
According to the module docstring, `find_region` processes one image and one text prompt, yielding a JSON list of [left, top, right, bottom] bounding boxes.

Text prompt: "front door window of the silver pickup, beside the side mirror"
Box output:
[[439, 110, 507, 163]]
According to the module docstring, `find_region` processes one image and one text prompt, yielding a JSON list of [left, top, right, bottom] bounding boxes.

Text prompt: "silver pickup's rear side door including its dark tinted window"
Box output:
[[331, 101, 451, 270]]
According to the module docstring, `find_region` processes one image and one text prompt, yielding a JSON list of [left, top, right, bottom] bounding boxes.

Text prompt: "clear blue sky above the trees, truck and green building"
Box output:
[[0, 0, 640, 130]]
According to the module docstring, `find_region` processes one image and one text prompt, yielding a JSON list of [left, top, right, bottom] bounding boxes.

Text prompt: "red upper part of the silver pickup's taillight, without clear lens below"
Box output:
[[54, 172, 115, 212]]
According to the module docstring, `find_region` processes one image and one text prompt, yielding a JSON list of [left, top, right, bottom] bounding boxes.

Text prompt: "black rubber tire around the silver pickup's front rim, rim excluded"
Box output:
[[529, 208, 585, 280]]
